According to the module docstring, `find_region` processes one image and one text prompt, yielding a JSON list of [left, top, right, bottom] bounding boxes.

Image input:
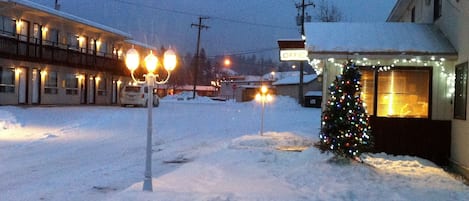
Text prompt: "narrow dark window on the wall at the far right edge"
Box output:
[[454, 62, 468, 120]]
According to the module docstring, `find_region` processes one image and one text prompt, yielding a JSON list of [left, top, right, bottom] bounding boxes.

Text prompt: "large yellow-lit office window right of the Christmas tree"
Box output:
[[361, 68, 431, 118]]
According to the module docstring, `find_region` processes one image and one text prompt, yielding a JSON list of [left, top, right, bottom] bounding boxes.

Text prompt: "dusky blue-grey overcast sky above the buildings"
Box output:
[[32, 0, 396, 57]]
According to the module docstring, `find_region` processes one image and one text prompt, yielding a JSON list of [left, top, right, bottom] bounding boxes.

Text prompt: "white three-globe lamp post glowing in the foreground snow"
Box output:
[[125, 47, 176, 191]]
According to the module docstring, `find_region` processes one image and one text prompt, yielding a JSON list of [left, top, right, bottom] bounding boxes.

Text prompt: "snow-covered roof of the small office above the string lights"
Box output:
[[305, 22, 457, 56]]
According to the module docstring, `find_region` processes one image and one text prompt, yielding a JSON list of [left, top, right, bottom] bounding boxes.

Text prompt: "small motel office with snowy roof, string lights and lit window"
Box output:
[[306, 23, 457, 164]]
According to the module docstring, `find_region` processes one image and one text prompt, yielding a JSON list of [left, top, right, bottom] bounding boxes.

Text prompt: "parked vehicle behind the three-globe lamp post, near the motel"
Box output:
[[119, 85, 160, 107]]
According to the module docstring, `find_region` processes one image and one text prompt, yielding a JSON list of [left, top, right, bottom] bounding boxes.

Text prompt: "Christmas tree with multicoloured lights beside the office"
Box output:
[[318, 62, 373, 159]]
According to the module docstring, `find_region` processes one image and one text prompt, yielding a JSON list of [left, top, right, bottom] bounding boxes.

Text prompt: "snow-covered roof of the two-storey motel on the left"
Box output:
[[0, 0, 132, 38]]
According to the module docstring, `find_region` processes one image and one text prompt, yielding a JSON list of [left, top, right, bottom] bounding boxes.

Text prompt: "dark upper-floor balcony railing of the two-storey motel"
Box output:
[[0, 35, 126, 74]]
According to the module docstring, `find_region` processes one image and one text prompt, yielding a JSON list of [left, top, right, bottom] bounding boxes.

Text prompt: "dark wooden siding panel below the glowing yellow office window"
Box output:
[[370, 117, 451, 165]]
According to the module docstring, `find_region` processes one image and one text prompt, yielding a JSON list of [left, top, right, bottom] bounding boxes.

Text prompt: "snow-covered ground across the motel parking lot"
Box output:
[[0, 97, 469, 201]]
